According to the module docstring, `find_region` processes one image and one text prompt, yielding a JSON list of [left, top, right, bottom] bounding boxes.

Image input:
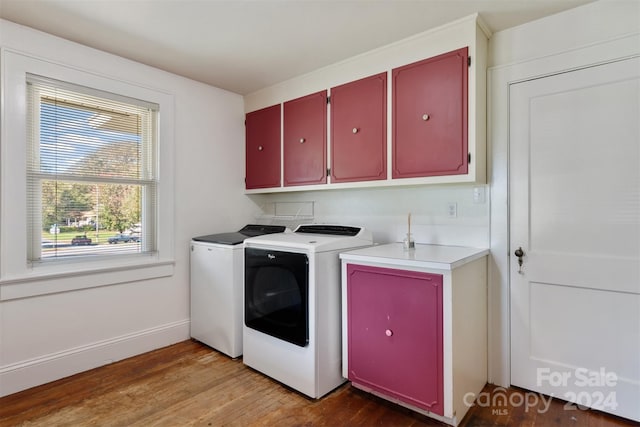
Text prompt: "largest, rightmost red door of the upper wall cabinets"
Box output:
[[392, 47, 468, 178]]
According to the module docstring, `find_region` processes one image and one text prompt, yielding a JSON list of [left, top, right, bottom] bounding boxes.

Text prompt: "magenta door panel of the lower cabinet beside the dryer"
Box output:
[[347, 264, 444, 415]]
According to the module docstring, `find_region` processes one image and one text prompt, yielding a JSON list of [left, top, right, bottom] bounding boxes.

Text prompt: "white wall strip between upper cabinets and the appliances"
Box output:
[[250, 184, 489, 248]]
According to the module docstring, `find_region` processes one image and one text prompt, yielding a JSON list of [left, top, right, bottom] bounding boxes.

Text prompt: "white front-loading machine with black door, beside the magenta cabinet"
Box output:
[[243, 224, 373, 398]]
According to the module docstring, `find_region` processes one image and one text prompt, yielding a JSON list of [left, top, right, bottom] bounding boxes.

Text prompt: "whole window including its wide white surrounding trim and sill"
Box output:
[[0, 49, 175, 301]]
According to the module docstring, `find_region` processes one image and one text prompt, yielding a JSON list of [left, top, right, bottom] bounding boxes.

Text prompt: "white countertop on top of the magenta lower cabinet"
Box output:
[[340, 243, 489, 270]]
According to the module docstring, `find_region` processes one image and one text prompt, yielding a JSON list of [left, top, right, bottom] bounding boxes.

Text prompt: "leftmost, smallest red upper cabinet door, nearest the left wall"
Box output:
[[245, 105, 280, 189]]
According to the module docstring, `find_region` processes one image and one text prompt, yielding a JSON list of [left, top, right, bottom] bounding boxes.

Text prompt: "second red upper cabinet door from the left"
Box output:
[[283, 91, 327, 186]]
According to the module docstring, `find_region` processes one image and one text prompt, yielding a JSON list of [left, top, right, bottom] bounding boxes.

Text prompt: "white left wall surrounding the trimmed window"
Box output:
[[0, 20, 255, 395]]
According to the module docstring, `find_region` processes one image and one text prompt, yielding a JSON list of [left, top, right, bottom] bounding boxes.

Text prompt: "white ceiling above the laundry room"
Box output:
[[0, 0, 593, 94]]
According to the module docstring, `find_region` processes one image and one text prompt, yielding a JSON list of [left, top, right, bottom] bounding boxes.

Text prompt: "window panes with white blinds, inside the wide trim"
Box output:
[[26, 74, 159, 263]]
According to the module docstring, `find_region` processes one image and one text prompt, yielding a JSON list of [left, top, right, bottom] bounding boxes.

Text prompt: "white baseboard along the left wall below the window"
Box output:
[[0, 319, 189, 397]]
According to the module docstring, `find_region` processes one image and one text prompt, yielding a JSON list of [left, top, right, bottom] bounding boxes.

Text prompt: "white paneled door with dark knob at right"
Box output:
[[509, 58, 640, 420]]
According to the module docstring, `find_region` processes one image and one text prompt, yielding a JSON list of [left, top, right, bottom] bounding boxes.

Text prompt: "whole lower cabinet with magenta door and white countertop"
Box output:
[[340, 243, 488, 426]]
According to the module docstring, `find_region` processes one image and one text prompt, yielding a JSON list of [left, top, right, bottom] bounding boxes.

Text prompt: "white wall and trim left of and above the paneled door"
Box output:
[[487, 0, 640, 386]]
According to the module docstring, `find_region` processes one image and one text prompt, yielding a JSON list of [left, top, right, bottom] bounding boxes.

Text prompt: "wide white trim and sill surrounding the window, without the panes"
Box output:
[[0, 48, 175, 301]]
